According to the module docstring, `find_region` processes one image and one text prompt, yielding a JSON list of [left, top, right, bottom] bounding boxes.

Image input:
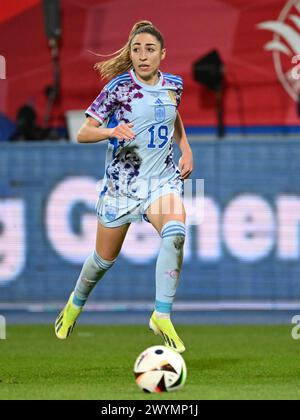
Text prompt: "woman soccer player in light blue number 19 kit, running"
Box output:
[[55, 21, 193, 353]]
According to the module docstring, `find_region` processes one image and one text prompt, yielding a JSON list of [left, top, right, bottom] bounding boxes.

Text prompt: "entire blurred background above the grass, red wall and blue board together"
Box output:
[[0, 0, 300, 324]]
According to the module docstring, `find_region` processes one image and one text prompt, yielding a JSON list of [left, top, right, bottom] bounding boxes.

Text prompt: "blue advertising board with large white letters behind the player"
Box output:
[[0, 139, 300, 303]]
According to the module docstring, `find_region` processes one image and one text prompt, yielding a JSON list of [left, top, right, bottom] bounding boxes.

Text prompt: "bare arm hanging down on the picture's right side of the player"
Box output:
[[174, 112, 193, 179]]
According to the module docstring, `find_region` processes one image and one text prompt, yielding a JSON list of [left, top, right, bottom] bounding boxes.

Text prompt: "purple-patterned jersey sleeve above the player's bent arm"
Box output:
[[85, 86, 118, 124]]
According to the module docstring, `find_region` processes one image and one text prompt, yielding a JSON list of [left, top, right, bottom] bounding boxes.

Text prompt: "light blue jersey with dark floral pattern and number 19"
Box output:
[[86, 70, 183, 200]]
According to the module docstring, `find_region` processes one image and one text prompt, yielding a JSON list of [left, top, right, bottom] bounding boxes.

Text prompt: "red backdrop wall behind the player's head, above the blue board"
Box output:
[[0, 0, 300, 125]]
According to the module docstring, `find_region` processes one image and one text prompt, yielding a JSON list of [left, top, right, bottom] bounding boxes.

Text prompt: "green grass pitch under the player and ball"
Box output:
[[0, 325, 300, 400]]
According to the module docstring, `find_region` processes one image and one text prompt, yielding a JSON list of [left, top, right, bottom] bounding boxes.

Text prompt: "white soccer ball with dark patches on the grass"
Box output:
[[133, 346, 187, 392]]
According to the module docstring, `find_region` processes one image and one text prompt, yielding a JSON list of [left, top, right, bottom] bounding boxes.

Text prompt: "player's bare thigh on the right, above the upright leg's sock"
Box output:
[[146, 194, 186, 233]]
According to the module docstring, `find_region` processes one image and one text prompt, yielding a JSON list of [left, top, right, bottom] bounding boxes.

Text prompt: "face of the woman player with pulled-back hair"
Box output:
[[130, 34, 166, 82]]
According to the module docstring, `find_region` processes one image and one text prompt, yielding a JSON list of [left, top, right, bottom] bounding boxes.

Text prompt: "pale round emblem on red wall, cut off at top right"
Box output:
[[257, 0, 300, 102]]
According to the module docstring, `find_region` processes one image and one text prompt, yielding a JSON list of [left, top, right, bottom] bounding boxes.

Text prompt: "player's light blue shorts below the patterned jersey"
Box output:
[[95, 178, 183, 227]]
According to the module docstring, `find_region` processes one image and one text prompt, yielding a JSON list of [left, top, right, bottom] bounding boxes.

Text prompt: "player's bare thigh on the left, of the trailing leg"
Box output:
[[96, 222, 130, 261]]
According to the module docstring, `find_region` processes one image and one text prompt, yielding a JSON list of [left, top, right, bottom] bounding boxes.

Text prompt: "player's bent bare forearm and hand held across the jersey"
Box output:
[[77, 117, 135, 143]]
